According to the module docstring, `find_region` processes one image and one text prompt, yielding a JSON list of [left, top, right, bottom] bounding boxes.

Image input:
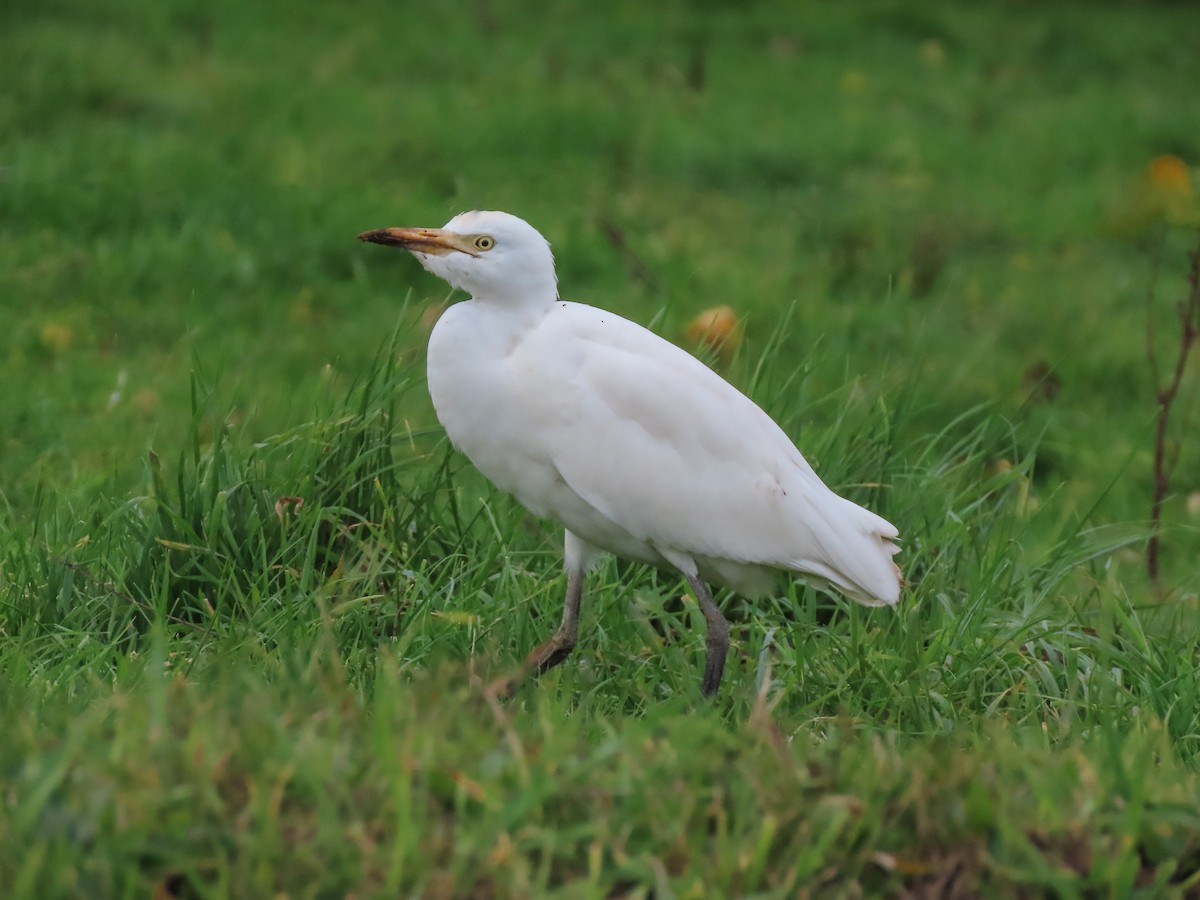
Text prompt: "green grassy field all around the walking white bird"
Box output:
[[0, 0, 1200, 900]]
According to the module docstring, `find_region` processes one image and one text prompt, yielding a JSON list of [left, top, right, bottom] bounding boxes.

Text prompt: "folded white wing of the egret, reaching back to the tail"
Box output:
[[516, 305, 898, 602]]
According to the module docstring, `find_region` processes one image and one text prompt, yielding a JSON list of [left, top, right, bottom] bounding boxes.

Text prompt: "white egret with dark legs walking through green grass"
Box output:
[[359, 211, 900, 695]]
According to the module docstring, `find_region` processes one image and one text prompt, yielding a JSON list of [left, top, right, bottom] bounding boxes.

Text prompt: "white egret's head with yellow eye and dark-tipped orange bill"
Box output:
[[359, 210, 558, 304]]
